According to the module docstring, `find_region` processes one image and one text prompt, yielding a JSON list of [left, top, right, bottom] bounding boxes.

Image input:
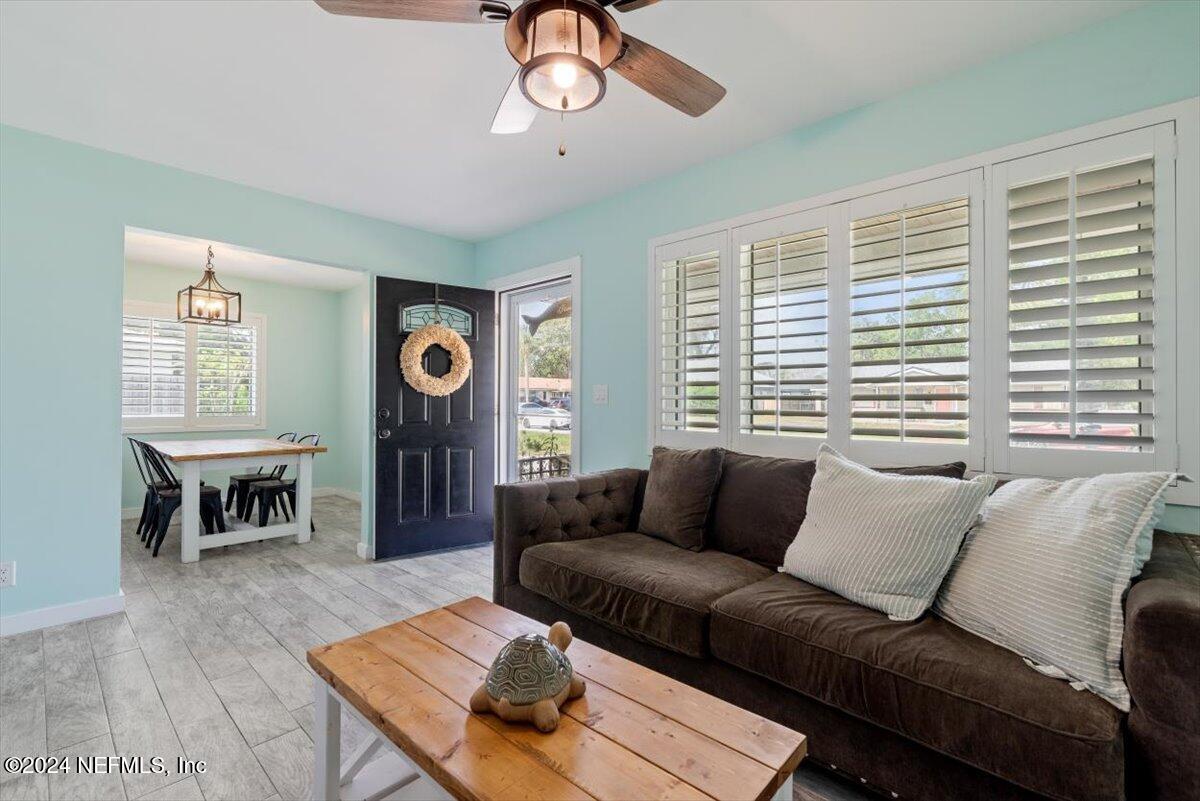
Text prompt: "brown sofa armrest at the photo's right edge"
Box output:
[[1124, 531, 1200, 799]]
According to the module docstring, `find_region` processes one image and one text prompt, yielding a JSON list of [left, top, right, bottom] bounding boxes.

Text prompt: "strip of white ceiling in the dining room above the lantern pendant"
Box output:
[[125, 228, 362, 291]]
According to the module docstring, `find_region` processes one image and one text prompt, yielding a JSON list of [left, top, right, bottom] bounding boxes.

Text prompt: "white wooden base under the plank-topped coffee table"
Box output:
[[312, 676, 451, 801]]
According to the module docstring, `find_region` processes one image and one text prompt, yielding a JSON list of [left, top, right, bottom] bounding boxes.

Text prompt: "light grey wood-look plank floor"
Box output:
[[0, 498, 866, 801]]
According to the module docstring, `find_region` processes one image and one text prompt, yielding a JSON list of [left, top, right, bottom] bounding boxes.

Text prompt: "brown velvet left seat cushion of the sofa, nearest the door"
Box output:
[[520, 532, 770, 657]]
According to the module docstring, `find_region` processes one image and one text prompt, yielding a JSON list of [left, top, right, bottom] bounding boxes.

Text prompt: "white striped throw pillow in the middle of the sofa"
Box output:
[[780, 445, 996, 620]]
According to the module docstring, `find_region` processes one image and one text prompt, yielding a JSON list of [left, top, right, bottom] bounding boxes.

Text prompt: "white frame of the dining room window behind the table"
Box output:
[[121, 301, 266, 434]]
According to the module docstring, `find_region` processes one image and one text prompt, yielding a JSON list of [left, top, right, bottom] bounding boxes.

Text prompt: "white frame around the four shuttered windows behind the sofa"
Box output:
[[647, 97, 1200, 506]]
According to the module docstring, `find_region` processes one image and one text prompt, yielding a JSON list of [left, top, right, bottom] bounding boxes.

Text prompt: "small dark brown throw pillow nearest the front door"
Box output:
[[637, 447, 725, 550]]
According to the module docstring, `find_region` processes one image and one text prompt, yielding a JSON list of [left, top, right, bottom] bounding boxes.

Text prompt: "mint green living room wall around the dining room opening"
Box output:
[[0, 126, 474, 615]]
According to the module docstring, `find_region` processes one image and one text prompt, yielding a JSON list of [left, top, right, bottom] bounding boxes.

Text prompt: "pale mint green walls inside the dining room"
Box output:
[[121, 264, 366, 508]]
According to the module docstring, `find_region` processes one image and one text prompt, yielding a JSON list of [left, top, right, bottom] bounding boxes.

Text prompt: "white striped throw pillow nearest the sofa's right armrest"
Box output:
[[935, 472, 1175, 711]]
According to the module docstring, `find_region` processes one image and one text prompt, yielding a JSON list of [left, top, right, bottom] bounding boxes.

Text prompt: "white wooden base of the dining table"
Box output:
[[176, 453, 312, 562]]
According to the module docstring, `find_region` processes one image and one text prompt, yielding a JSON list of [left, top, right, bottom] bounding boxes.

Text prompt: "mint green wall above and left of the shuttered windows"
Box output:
[[475, 2, 1200, 531]]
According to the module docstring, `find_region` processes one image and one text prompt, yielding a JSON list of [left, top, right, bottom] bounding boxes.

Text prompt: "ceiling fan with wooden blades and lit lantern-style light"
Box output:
[[316, 0, 725, 133]]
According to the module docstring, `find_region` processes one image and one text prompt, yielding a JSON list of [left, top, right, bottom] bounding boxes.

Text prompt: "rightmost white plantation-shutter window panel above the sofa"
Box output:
[[997, 123, 1175, 474]]
